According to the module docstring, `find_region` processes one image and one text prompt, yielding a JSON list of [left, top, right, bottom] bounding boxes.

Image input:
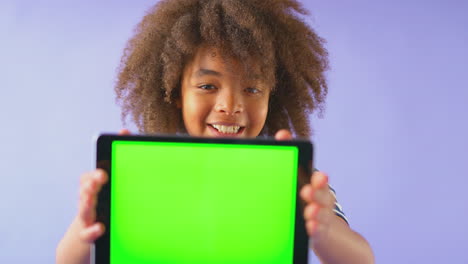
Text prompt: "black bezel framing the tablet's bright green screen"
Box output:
[[92, 134, 313, 264]]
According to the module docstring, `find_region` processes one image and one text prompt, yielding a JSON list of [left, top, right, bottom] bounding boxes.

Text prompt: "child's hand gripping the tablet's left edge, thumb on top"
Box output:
[[77, 129, 130, 243]]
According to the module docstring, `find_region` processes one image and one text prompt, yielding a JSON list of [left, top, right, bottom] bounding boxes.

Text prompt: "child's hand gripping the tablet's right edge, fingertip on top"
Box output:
[[275, 129, 335, 240]]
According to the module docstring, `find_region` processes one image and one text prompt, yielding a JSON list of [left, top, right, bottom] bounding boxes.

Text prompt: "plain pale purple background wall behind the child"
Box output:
[[0, 0, 468, 264]]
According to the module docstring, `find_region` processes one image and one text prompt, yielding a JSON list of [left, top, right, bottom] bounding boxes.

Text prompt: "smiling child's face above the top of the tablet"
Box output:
[[178, 47, 270, 138]]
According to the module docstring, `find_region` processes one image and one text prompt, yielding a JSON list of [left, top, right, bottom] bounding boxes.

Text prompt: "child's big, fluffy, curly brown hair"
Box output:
[[115, 0, 328, 137]]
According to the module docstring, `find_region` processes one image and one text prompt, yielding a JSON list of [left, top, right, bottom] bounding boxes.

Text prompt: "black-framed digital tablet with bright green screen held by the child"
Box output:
[[93, 135, 312, 264]]
